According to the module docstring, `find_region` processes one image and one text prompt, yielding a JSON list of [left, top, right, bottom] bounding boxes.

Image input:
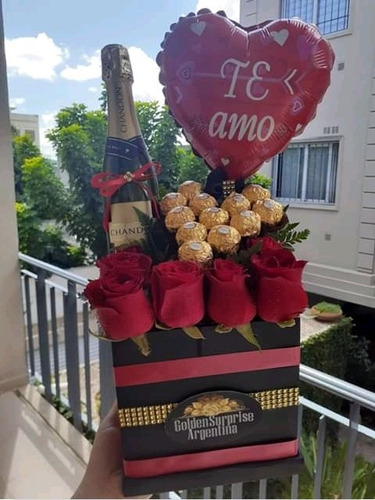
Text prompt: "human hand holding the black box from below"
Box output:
[[72, 405, 151, 498]]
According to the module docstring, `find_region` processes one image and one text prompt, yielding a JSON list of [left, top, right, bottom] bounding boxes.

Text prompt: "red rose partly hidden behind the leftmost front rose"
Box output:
[[96, 247, 152, 285]]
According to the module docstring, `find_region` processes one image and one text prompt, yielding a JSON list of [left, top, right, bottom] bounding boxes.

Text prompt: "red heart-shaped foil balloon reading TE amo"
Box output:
[[157, 10, 335, 179]]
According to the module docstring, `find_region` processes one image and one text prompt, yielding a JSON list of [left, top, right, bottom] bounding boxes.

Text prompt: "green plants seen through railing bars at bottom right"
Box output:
[[276, 434, 375, 499]]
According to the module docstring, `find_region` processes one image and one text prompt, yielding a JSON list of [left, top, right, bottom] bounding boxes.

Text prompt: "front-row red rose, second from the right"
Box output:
[[207, 259, 256, 326]]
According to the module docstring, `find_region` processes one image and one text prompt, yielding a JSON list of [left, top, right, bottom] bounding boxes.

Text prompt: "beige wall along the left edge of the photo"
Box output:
[[0, 0, 26, 392]]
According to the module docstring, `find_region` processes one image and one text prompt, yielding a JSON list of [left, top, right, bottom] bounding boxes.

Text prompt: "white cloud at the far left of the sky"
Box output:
[[5, 33, 69, 80]]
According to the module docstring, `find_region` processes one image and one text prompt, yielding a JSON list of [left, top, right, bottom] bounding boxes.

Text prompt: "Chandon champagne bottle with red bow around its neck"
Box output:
[[101, 45, 157, 251]]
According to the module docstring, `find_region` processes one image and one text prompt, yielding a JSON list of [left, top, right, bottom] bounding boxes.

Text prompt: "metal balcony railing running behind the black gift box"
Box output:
[[20, 254, 375, 498]]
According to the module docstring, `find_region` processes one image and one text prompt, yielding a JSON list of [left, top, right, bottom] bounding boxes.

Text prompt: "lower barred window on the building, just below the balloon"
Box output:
[[274, 142, 339, 205]]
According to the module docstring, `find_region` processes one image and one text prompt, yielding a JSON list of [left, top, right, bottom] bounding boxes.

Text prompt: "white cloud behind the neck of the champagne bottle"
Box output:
[[60, 47, 164, 102]]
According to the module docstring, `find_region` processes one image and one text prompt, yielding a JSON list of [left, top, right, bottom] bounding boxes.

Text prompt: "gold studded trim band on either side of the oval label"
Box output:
[[118, 387, 299, 427]]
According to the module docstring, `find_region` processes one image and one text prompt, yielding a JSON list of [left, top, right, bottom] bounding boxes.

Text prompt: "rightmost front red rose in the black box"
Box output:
[[251, 248, 307, 323]]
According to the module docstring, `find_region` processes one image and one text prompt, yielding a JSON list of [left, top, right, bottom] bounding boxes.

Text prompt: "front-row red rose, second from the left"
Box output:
[[151, 261, 204, 328]]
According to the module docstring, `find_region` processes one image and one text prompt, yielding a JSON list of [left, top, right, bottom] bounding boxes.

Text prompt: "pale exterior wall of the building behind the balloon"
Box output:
[[241, 0, 375, 306]]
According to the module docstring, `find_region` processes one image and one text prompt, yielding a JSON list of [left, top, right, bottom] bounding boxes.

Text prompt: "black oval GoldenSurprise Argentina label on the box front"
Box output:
[[165, 391, 262, 445]]
